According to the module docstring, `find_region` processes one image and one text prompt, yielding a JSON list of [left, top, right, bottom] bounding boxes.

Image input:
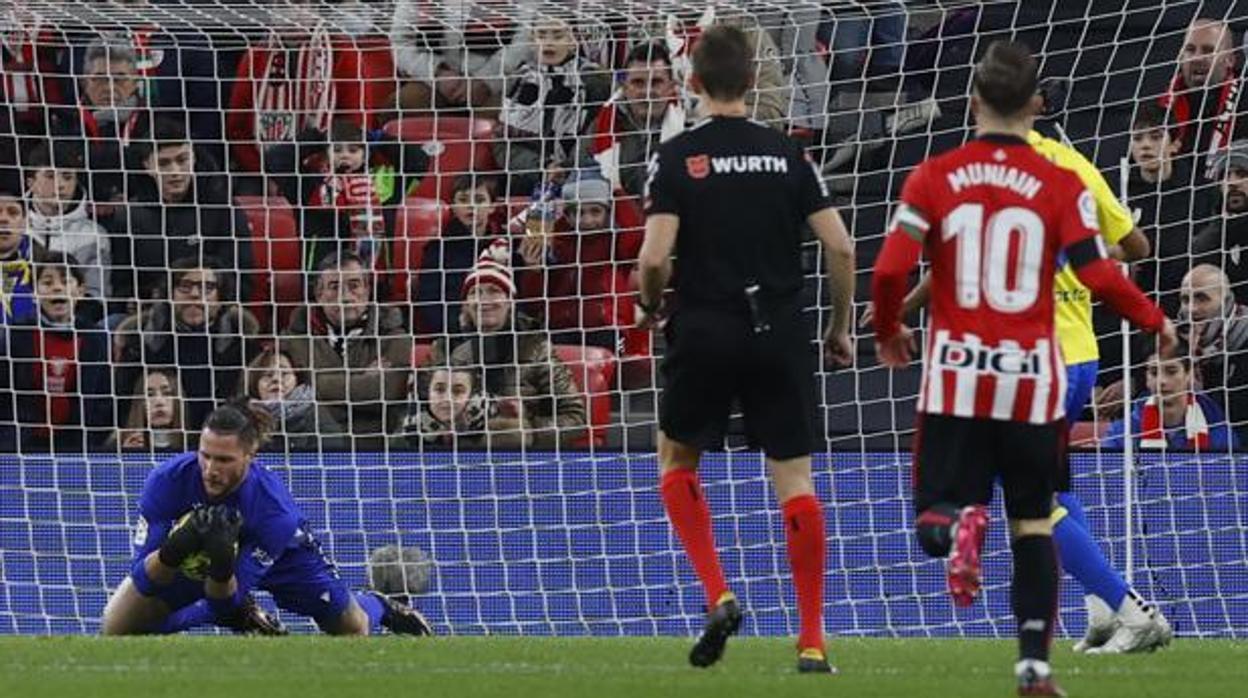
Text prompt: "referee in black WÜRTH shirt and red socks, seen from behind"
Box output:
[[639, 25, 854, 673]]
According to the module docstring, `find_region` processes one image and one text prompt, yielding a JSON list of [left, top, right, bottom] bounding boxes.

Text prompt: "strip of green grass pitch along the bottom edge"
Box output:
[[0, 637, 1248, 698]]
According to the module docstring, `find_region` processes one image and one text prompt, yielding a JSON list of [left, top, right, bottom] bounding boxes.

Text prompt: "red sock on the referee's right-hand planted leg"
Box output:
[[782, 494, 826, 651]]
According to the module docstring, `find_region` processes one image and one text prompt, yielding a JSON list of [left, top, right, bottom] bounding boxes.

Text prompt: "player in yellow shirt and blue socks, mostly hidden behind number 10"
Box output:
[[864, 125, 1171, 653]]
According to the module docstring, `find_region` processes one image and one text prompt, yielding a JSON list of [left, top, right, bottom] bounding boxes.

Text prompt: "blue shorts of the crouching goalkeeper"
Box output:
[[156, 546, 352, 627]]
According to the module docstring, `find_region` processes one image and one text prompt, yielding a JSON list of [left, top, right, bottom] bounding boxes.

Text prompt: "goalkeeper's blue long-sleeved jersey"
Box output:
[[135, 452, 321, 591]]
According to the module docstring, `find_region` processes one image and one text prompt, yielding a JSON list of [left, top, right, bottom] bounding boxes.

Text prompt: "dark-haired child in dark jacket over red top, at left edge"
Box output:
[[5, 253, 115, 453]]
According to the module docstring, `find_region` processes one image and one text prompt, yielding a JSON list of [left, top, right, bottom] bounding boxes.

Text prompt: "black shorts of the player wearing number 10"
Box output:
[[914, 415, 1067, 518]]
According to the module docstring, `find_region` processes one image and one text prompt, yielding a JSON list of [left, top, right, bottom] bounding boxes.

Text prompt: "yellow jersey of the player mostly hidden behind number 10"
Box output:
[[1027, 131, 1136, 366]]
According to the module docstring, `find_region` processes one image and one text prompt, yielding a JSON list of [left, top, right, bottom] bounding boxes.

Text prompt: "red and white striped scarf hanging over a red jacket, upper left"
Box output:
[[255, 26, 336, 144]]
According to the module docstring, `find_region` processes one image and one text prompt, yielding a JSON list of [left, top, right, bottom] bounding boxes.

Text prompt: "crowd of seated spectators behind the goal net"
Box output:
[[0, 0, 1248, 452]]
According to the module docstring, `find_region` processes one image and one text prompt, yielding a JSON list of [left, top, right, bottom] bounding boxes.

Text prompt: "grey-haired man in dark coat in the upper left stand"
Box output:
[[52, 40, 151, 204]]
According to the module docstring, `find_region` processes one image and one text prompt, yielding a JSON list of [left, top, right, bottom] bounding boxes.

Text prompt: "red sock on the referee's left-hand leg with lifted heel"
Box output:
[[659, 468, 728, 608]]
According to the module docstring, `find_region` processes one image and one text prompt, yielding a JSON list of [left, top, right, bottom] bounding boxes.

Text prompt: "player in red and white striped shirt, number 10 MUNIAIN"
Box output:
[[872, 41, 1174, 696]]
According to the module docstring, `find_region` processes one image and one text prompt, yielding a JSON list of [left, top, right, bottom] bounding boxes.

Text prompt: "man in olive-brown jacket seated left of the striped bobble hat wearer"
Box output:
[[278, 251, 412, 448]]
